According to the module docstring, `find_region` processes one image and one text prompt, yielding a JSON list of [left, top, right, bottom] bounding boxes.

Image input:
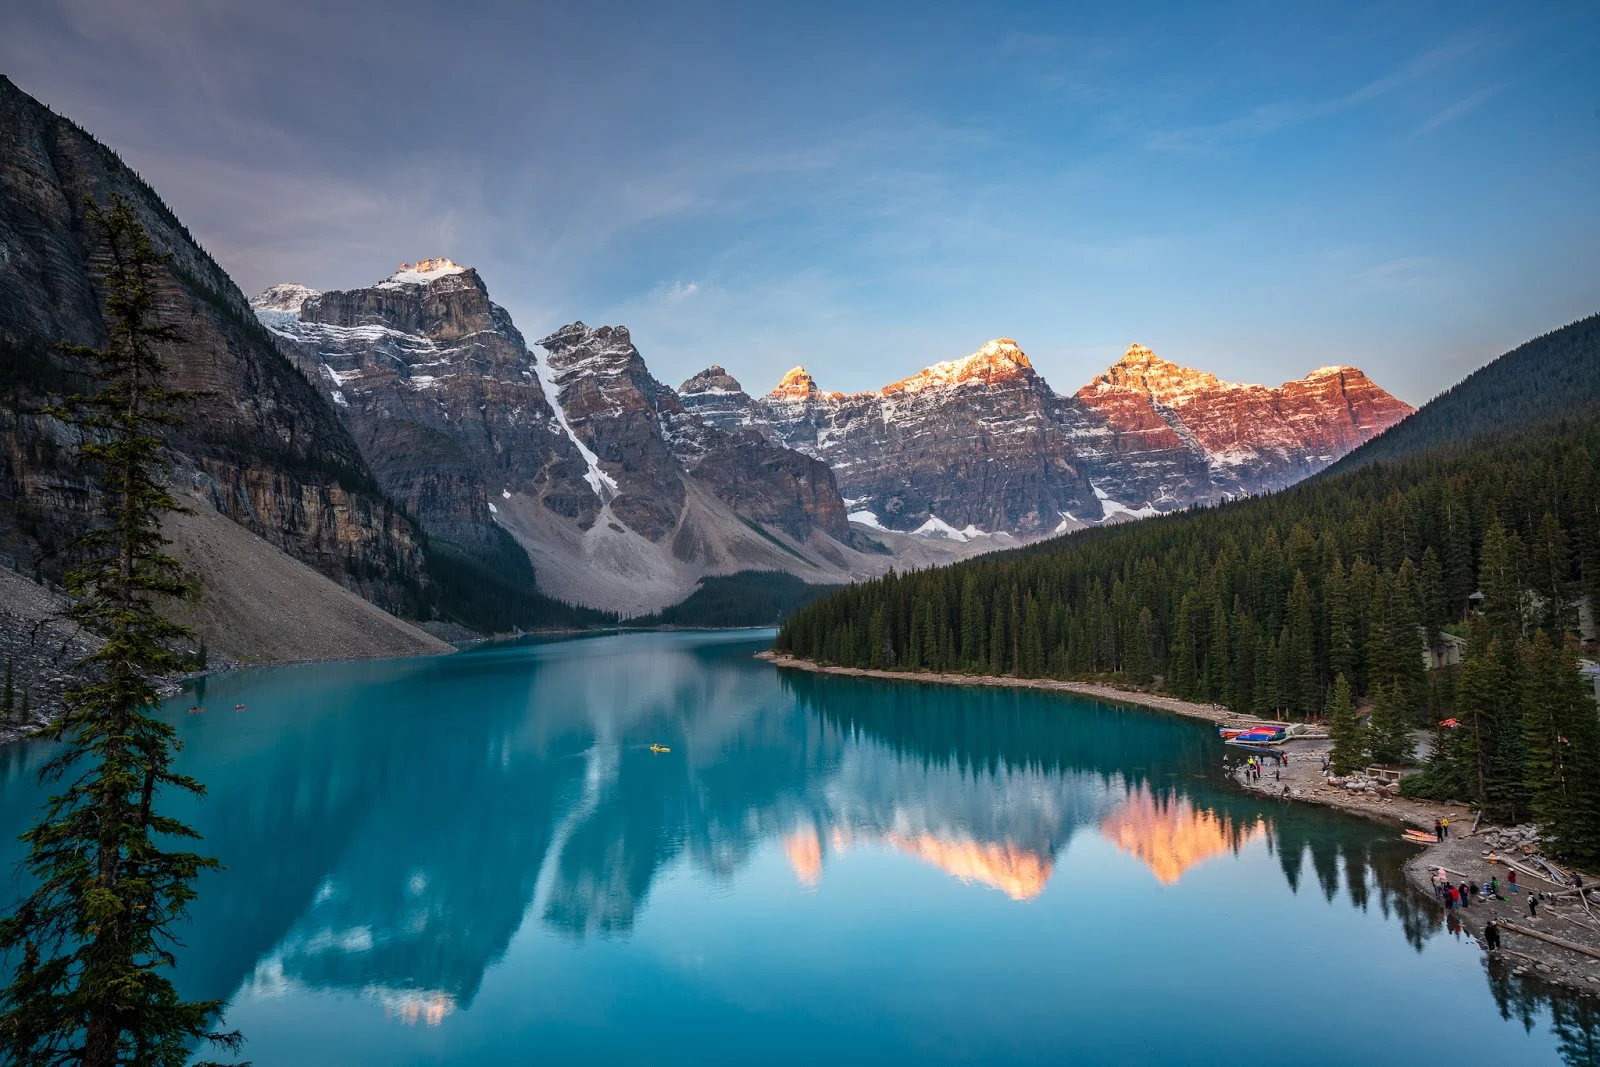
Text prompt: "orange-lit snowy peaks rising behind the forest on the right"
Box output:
[[680, 338, 1410, 537]]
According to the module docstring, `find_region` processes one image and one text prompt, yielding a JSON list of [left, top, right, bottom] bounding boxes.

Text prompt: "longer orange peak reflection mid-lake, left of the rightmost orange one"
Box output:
[[782, 827, 1053, 901]]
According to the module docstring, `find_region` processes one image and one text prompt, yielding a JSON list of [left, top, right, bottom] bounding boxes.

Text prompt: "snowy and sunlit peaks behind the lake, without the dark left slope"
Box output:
[[251, 258, 1411, 616]]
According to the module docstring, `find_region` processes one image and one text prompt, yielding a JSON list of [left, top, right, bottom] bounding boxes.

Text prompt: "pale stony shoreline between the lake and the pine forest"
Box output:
[[755, 649, 1600, 997]]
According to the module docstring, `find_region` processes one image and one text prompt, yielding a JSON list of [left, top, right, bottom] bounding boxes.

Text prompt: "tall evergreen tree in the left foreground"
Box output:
[[0, 197, 240, 1067]]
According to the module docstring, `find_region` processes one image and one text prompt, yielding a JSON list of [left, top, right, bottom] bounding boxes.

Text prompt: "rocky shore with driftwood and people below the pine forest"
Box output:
[[757, 651, 1600, 997]]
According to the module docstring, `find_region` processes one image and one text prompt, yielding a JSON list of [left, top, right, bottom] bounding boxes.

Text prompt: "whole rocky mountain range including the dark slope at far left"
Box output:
[[0, 70, 1410, 657]]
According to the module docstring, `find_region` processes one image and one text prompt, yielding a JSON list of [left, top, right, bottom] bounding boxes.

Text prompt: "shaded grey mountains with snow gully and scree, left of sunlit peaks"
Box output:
[[251, 271, 992, 616]]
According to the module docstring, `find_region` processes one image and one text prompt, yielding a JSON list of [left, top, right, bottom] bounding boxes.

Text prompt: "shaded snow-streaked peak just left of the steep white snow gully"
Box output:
[[251, 259, 598, 549]]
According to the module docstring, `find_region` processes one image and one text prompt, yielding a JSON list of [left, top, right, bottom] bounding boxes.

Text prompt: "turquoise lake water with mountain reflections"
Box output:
[[0, 632, 1580, 1067]]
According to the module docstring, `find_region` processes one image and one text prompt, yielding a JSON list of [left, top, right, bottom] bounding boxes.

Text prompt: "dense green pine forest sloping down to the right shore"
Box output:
[[776, 414, 1600, 859]]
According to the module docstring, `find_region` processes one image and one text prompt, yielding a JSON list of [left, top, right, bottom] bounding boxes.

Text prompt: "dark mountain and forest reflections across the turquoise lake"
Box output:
[[0, 635, 1595, 1064]]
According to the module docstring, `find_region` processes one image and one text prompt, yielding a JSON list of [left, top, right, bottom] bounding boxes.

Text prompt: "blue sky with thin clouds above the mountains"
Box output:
[[0, 0, 1600, 403]]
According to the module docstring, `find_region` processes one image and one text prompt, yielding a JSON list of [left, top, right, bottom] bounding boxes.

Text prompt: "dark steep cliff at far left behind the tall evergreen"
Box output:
[[0, 77, 422, 608]]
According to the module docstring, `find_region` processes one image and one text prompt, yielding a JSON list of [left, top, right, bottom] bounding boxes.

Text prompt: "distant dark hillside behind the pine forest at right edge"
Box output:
[[1323, 315, 1600, 477]]
